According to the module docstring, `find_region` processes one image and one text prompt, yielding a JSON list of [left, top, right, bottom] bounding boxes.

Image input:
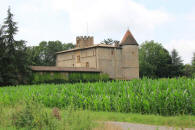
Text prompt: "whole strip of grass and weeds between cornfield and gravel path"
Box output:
[[0, 102, 195, 130]]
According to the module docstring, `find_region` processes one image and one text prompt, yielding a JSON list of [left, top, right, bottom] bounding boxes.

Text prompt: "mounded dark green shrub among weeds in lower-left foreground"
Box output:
[[12, 101, 57, 130]]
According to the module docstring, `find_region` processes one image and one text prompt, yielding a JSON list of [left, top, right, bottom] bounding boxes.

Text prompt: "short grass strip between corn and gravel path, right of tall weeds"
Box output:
[[89, 111, 195, 128]]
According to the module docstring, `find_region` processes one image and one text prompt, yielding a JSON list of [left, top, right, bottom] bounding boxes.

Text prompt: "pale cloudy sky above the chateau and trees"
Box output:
[[0, 0, 195, 63]]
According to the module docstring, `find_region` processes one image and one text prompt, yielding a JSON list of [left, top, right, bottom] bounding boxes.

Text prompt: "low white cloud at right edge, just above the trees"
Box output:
[[165, 39, 195, 64]]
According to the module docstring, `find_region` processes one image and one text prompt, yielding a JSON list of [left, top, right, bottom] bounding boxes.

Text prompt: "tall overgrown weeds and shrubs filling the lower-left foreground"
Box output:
[[0, 101, 95, 130]]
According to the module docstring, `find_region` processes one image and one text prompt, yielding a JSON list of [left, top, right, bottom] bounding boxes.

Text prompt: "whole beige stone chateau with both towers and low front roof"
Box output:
[[32, 30, 139, 80]]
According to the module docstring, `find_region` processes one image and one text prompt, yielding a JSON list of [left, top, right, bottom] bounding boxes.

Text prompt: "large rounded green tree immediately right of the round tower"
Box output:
[[139, 41, 171, 77]]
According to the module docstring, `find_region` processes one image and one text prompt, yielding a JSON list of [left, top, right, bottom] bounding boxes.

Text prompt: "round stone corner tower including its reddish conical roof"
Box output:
[[120, 30, 139, 79]]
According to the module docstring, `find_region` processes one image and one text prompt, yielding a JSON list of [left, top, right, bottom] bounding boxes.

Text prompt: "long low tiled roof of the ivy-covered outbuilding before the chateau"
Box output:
[[31, 66, 100, 72]]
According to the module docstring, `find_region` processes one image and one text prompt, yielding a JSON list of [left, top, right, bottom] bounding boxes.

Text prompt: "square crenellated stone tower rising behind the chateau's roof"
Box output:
[[76, 36, 94, 48]]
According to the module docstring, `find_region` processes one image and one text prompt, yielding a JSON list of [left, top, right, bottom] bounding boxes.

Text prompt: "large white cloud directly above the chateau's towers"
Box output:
[[51, 0, 170, 37]]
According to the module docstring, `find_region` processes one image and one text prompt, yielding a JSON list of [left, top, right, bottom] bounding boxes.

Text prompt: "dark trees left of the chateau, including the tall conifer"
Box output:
[[0, 8, 74, 86]]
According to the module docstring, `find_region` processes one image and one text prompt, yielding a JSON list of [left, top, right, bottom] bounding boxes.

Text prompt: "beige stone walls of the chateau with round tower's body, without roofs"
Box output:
[[56, 45, 139, 80]]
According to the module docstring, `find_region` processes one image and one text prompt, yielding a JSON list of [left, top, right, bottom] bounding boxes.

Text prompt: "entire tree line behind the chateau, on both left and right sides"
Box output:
[[0, 8, 195, 86]]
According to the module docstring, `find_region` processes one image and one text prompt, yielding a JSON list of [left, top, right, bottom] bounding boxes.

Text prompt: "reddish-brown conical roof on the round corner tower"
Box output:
[[120, 29, 138, 46]]
